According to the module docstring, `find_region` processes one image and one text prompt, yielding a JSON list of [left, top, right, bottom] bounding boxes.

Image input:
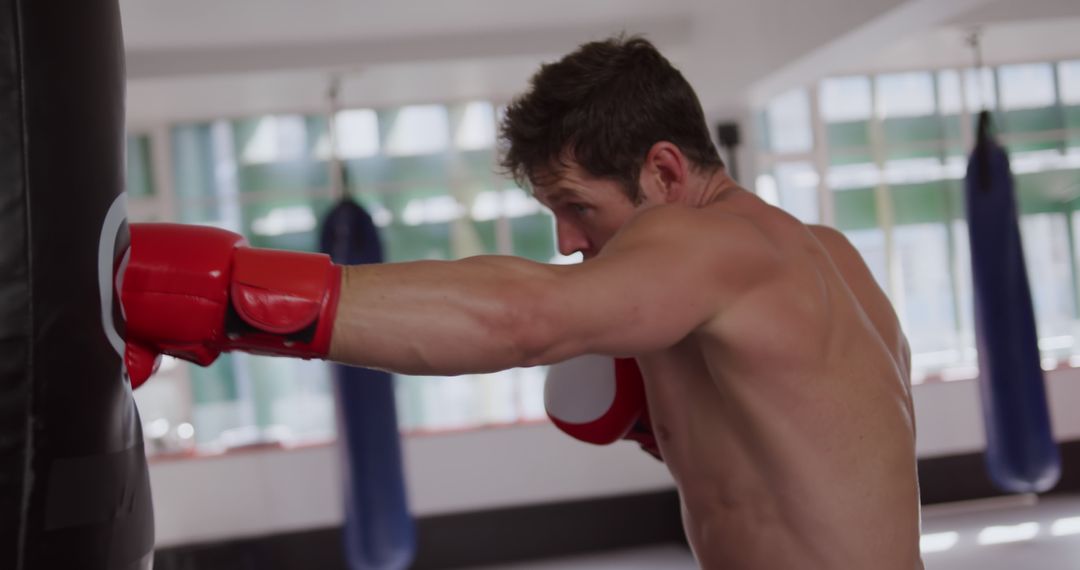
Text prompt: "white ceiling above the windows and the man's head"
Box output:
[[120, 0, 1080, 126]]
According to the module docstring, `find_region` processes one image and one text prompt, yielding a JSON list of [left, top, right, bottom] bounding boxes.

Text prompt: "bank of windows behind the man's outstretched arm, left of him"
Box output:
[[129, 101, 558, 452]]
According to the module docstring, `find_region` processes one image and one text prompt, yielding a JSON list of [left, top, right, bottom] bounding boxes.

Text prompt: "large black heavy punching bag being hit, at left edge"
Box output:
[[0, 0, 153, 570]]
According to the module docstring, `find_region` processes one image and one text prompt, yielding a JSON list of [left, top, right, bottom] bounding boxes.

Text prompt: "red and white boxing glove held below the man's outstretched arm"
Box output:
[[544, 354, 661, 459]]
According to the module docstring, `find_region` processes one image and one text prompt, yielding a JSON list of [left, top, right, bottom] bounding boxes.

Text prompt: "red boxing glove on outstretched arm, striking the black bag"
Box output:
[[116, 223, 341, 388]]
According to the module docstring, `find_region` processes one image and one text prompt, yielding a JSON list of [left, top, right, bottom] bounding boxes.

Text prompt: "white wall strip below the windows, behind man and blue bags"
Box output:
[[150, 369, 1080, 547]]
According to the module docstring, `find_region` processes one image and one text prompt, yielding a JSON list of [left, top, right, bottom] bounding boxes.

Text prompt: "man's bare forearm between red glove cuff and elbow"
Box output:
[[329, 256, 566, 375]]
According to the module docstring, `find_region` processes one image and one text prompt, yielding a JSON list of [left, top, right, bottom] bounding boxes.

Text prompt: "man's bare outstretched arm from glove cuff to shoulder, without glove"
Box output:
[[329, 207, 777, 375]]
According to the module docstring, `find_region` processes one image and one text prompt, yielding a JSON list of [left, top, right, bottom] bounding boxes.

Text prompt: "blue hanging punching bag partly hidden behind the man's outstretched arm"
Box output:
[[322, 193, 416, 570]]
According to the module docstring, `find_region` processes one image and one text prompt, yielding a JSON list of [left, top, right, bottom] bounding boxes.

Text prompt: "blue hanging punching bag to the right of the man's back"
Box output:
[[964, 111, 1061, 492]]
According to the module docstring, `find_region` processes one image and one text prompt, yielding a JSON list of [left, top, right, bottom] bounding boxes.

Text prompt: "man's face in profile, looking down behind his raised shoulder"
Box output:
[[534, 164, 637, 259]]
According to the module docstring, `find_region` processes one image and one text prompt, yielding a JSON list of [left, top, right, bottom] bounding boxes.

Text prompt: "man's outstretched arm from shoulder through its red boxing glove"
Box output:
[[118, 207, 777, 383]]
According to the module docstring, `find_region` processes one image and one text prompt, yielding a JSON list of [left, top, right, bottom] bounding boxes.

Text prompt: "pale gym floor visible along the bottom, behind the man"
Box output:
[[475, 497, 1080, 570]]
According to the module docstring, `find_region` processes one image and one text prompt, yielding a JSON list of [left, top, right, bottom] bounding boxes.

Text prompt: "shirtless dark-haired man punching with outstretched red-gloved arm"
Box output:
[[124, 38, 922, 570]]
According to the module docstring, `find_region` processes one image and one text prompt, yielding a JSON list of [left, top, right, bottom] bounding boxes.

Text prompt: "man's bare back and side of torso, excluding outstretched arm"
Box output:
[[638, 192, 921, 570]]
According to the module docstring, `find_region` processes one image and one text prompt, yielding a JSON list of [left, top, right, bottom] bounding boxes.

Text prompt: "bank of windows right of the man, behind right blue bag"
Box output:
[[756, 56, 1080, 382]]
